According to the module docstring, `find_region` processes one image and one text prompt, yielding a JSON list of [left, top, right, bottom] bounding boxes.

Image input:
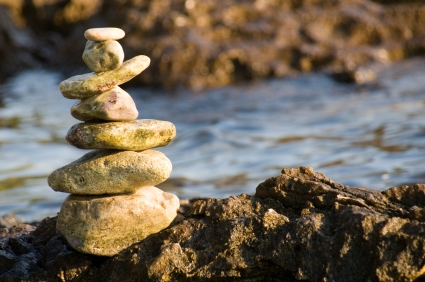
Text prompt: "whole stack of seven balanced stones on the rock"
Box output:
[[48, 28, 179, 256]]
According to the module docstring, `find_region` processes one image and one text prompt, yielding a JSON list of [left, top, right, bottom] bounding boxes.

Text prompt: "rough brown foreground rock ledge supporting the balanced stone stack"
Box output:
[[0, 167, 425, 281]]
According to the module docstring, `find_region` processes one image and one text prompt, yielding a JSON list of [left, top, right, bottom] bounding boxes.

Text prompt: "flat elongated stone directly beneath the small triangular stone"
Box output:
[[66, 119, 176, 151]]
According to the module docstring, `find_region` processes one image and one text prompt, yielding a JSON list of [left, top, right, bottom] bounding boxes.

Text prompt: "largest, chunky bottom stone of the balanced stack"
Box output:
[[56, 187, 180, 256]]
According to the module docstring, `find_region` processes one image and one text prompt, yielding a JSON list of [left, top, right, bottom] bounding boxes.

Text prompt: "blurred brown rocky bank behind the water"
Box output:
[[0, 0, 425, 89]]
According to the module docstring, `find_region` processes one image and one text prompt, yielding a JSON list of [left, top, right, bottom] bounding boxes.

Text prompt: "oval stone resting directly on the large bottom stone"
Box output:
[[47, 150, 172, 195]]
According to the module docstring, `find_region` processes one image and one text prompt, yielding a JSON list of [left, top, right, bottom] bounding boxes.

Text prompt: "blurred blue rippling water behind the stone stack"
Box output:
[[0, 59, 425, 221]]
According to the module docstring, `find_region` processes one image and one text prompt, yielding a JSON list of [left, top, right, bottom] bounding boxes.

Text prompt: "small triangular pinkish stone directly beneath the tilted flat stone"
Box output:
[[71, 86, 139, 121]]
